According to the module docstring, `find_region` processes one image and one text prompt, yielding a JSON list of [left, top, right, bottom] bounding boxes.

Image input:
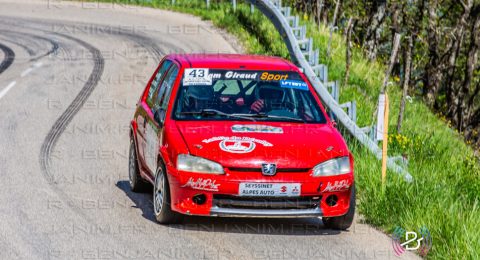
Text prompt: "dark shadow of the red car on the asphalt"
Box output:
[[116, 181, 342, 236]]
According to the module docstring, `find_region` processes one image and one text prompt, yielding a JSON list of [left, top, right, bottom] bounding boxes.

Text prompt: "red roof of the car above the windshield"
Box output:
[[167, 53, 298, 71]]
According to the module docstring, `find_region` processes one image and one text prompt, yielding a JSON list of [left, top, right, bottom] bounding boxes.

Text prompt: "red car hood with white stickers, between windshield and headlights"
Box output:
[[176, 121, 349, 170]]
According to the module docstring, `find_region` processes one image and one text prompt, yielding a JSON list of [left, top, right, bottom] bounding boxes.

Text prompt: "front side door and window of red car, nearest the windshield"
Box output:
[[145, 63, 179, 177]]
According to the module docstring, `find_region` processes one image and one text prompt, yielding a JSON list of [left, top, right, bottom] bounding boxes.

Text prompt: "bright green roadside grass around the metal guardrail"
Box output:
[[92, 0, 480, 259]]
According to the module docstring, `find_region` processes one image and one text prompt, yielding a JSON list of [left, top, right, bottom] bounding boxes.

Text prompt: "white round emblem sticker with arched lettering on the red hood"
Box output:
[[202, 136, 273, 153]]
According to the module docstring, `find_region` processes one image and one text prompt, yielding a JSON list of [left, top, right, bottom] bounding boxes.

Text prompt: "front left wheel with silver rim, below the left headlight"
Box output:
[[153, 165, 180, 224]]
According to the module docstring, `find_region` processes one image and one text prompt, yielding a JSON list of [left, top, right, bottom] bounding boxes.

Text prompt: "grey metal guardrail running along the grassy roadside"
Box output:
[[247, 0, 413, 181]]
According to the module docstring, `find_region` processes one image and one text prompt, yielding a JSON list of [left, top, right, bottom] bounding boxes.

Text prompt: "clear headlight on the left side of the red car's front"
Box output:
[[177, 154, 224, 174]]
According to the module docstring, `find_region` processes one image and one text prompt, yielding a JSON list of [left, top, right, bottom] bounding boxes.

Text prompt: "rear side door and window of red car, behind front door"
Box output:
[[135, 60, 172, 170]]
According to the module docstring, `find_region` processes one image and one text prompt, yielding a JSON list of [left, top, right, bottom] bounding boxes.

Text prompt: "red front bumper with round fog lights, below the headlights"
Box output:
[[167, 167, 354, 218]]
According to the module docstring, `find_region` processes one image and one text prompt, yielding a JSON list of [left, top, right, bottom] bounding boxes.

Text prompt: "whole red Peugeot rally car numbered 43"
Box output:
[[129, 54, 355, 229]]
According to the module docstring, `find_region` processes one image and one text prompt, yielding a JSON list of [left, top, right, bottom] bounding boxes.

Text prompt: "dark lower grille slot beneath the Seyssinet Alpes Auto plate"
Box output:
[[213, 194, 321, 209]]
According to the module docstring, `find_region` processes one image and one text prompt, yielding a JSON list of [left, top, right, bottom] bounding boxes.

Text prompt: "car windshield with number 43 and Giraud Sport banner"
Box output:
[[174, 68, 326, 123]]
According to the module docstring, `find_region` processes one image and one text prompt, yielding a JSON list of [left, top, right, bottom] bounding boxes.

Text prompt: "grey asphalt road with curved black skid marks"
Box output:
[[0, 0, 416, 259]]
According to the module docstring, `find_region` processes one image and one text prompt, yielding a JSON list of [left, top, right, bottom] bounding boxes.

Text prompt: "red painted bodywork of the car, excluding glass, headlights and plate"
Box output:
[[131, 54, 354, 217]]
